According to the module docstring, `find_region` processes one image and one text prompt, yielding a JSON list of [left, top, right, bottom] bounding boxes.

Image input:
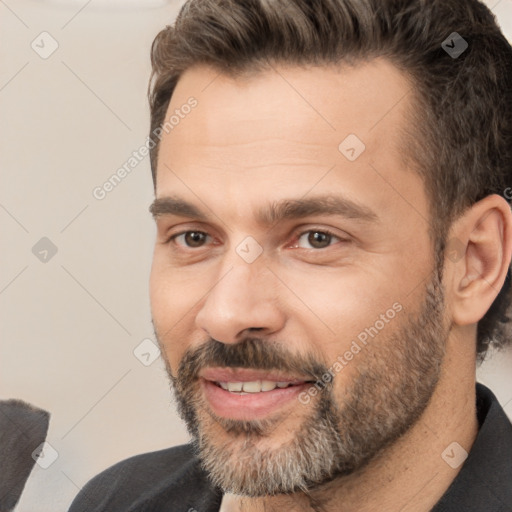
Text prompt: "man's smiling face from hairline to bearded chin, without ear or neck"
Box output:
[[151, 61, 447, 496]]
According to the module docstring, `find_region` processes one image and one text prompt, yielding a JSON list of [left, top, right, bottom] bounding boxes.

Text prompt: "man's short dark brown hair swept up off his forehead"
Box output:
[[149, 0, 512, 360]]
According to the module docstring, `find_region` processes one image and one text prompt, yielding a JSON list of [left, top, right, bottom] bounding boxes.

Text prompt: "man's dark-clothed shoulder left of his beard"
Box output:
[[69, 444, 222, 512]]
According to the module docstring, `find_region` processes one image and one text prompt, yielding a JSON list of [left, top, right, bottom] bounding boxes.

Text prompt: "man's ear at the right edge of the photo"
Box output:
[[445, 194, 512, 326]]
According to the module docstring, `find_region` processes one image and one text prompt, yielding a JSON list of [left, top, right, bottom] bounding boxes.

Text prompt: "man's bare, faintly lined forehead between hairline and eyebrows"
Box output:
[[157, 59, 426, 226]]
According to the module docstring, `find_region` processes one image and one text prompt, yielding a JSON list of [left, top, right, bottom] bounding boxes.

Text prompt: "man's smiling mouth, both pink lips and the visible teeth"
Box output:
[[199, 368, 314, 421]]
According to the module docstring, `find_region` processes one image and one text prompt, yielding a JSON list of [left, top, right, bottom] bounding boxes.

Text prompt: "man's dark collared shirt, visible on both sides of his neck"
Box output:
[[69, 384, 512, 512]]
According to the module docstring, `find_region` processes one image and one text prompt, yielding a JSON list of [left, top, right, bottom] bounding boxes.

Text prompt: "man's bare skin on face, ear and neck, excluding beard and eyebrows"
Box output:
[[150, 60, 512, 512]]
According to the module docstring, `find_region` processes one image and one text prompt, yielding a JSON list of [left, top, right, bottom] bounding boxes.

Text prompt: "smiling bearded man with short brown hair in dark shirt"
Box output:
[[71, 0, 512, 512]]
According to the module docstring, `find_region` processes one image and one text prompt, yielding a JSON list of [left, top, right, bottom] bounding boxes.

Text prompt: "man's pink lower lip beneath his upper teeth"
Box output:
[[201, 379, 311, 421]]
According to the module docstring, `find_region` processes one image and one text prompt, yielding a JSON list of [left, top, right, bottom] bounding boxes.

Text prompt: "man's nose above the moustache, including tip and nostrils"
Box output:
[[196, 262, 285, 344]]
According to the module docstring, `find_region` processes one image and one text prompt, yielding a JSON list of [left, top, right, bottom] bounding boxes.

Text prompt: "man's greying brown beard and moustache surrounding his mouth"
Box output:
[[157, 272, 449, 497]]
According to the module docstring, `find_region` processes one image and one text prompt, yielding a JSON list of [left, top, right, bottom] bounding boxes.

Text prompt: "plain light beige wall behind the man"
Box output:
[[0, 0, 512, 512]]
